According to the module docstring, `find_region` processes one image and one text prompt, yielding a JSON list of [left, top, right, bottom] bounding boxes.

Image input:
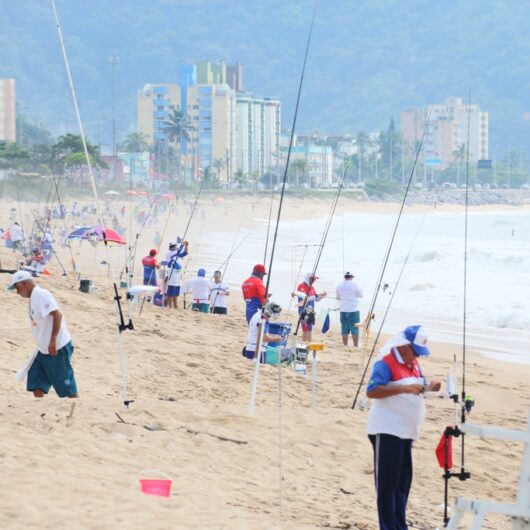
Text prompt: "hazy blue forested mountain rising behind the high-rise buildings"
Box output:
[[0, 0, 530, 155]]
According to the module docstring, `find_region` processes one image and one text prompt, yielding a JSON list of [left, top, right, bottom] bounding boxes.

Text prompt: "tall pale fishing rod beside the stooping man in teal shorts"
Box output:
[[50, 0, 134, 407]]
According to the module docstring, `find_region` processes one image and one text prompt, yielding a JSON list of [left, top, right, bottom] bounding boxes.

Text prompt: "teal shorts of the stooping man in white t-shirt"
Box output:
[[26, 341, 77, 397]]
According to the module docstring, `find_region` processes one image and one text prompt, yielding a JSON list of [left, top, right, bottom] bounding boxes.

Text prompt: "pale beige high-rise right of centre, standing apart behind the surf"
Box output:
[[401, 97, 489, 169]]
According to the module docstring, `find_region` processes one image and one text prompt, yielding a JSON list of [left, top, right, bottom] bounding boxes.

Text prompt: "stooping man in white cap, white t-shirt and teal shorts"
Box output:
[[8, 271, 78, 398]]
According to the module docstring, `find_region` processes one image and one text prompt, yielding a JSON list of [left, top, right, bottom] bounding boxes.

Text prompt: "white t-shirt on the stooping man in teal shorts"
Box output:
[[29, 286, 72, 354]]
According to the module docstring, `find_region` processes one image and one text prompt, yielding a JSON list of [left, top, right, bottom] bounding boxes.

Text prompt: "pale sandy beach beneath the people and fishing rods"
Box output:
[[0, 191, 530, 530]]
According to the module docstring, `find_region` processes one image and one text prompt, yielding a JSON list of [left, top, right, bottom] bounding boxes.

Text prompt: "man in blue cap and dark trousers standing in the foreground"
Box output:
[[366, 326, 440, 530]]
